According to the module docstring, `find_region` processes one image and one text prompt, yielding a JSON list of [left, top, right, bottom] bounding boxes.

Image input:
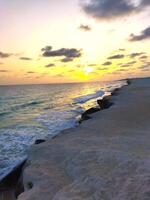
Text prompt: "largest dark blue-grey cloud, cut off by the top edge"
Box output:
[[81, 0, 150, 20]]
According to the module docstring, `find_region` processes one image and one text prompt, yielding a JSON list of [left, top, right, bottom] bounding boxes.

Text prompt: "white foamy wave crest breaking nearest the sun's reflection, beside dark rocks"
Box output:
[[74, 90, 105, 103]]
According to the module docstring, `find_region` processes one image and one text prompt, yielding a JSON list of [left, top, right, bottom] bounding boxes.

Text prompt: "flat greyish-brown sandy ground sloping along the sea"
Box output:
[[19, 78, 150, 200]]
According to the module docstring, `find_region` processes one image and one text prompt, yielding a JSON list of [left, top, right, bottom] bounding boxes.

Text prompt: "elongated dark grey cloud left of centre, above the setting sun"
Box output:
[[41, 46, 82, 62]]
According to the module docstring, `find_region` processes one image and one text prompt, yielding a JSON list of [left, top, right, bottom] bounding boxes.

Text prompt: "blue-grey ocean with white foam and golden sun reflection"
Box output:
[[0, 80, 126, 179]]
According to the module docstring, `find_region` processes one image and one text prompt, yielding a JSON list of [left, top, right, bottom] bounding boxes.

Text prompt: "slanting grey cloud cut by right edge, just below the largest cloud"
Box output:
[[129, 27, 150, 42]]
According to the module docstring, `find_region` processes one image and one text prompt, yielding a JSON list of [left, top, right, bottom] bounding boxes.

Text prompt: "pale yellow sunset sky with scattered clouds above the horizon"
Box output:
[[0, 0, 150, 85]]
